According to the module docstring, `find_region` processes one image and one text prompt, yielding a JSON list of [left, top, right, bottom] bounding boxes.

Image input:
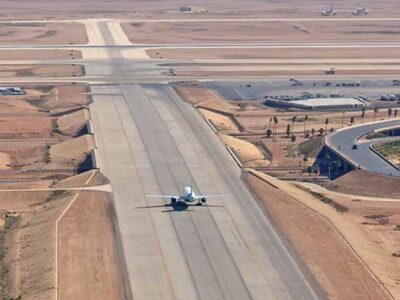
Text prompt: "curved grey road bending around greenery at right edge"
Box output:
[[325, 119, 400, 176]]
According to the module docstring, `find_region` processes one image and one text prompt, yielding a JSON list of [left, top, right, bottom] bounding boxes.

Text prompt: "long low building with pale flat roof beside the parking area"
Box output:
[[264, 98, 368, 110]]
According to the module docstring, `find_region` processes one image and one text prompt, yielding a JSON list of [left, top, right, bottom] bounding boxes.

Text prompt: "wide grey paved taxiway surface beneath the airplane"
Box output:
[[84, 20, 325, 300]]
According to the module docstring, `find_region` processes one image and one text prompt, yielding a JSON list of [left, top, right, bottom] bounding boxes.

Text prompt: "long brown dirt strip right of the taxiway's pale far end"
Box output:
[[123, 19, 400, 44]]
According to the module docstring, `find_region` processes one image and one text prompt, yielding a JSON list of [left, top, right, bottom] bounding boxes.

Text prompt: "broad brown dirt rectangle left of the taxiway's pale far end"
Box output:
[[0, 23, 88, 45]]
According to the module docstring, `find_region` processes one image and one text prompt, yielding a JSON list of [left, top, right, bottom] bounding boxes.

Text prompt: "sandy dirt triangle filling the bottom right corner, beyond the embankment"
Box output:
[[292, 179, 400, 299]]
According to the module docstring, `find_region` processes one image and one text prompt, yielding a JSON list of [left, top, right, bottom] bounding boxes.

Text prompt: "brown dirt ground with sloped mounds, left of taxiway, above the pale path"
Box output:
[[0, 85, 91, 180]]
